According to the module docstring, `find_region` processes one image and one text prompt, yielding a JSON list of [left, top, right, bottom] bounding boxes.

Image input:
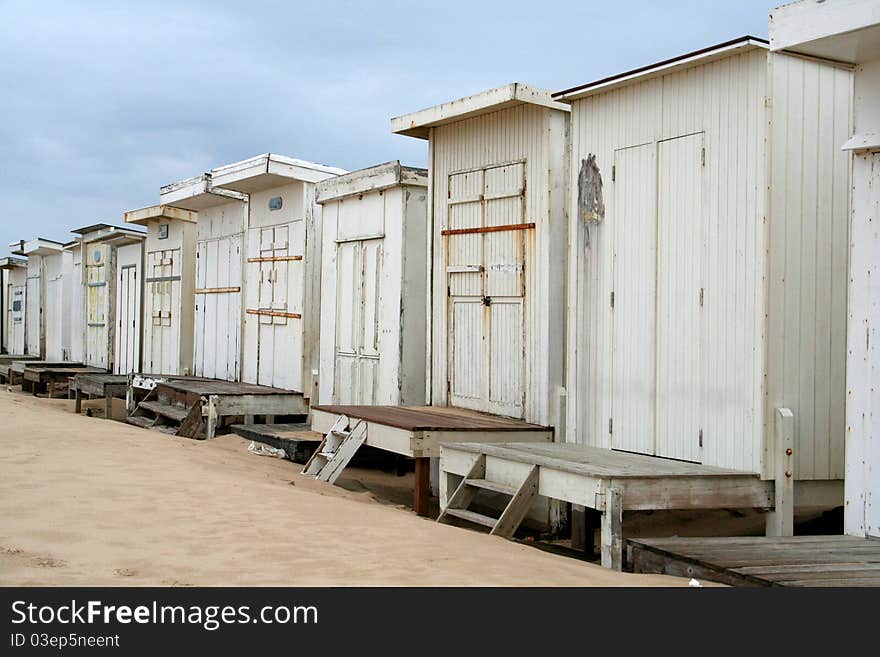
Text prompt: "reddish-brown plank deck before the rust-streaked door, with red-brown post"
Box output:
[[312, 405, 553, 516]]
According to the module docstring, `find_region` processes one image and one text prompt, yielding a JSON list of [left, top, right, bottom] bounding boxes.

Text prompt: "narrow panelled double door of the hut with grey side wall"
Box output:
[[334, 239, 383, 404]]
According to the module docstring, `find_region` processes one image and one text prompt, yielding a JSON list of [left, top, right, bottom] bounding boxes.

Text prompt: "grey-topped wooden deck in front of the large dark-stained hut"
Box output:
[[440, 442, 773, 570]]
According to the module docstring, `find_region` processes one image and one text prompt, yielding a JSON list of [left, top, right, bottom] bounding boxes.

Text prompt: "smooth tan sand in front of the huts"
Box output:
[[0, 388, 687, 586]]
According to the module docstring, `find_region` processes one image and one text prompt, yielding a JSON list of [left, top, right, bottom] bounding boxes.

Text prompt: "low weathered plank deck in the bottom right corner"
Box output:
[[626, 536, 880, 587]]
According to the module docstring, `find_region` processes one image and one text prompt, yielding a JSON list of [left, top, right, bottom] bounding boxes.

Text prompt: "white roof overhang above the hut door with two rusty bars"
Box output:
[[211, 153, 348, 194]]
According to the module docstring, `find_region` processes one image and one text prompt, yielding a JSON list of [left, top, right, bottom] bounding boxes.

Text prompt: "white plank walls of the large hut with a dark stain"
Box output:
[[565, 42, 851, 480]]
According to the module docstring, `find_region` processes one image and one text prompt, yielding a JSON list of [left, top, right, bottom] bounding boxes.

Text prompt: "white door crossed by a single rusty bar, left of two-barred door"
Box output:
[[193, 234, 242, 381]]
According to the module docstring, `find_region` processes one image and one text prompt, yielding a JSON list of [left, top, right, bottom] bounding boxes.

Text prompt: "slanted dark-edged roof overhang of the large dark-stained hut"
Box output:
[[553, 36, 768, 103]]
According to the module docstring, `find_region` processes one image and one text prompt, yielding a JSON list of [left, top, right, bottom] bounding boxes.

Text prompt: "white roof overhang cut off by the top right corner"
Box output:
[[770, 0, 880, 64]]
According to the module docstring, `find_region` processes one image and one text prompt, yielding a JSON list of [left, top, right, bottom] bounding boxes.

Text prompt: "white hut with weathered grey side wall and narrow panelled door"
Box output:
[[317, 162, 428, 405]]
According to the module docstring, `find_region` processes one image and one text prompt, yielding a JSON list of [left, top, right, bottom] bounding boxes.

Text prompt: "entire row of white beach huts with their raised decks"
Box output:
[[0, 0, 880, 580]]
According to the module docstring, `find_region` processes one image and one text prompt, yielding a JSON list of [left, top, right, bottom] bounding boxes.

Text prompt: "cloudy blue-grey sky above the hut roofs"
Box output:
[[0, 0, 782, 250]]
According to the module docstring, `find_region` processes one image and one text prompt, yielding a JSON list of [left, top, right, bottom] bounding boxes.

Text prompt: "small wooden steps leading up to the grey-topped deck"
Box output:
[[437, 454, 538, 538]]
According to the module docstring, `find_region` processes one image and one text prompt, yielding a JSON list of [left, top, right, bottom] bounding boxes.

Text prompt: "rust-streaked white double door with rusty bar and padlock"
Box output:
[[443, 162, 534, 417]]
